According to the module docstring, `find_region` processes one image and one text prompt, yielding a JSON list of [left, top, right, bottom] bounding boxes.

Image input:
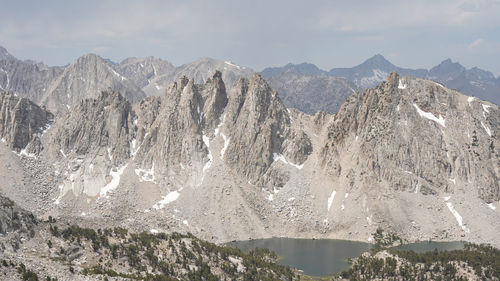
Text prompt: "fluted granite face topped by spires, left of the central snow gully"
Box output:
[[132, 72, 227, 187]]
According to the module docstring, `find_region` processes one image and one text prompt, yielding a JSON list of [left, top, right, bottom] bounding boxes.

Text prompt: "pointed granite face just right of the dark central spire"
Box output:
[[224, 75, 312, 186]]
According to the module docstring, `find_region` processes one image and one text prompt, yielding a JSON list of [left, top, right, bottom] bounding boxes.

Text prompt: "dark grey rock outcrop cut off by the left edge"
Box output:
[[0, 92, 53, 153]]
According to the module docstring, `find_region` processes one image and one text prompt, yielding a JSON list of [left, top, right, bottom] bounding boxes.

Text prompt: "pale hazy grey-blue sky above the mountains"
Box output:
[[0, 0, 500, 76]]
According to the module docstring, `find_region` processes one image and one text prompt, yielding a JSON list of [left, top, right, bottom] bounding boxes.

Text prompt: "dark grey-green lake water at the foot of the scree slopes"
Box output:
[[228, 238, 464, 276]]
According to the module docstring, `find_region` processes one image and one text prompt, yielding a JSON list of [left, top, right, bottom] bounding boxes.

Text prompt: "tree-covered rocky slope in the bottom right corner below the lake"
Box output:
[[338, 244, 500, 281]]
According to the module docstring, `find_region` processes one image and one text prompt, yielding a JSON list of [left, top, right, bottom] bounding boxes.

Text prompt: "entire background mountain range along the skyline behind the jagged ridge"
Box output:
[[0, 44, 500, 114]]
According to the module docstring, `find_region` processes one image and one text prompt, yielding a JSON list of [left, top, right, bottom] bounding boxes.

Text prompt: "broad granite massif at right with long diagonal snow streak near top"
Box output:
[[322, 73, 500, 203]]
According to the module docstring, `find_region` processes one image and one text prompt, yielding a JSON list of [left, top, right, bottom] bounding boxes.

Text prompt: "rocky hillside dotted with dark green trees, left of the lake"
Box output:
[[0, 196, 297, 281]]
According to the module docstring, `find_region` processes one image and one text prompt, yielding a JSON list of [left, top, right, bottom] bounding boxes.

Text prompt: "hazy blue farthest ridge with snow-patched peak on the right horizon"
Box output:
[[260, 54, 500, 104]]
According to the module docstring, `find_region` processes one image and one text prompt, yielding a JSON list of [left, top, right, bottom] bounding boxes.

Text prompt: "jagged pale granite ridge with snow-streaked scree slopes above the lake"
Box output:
[[0, 63, 500, 247]]
